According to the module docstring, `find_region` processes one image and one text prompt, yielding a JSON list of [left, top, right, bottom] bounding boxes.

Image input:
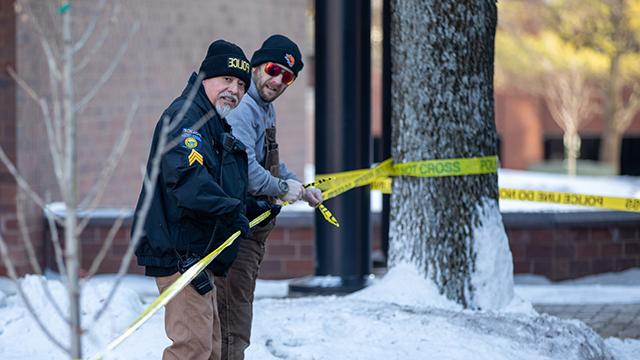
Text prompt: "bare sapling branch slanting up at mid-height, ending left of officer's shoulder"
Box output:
[[77, 99, 139, 235]]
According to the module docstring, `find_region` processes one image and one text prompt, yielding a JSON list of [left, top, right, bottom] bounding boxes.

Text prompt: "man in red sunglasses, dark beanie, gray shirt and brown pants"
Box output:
[[215, 35, 322, 360]]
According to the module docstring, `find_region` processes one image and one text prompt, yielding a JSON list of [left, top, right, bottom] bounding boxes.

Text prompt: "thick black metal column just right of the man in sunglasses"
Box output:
[[292, 0, 371, 292]]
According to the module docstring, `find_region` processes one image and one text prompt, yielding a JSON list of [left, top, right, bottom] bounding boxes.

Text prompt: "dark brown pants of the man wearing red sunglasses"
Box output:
[[215, 220, 276, 360]]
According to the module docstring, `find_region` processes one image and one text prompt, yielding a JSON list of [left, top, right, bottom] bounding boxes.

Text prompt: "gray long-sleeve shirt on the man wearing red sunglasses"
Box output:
[[226, 81, 298, 197]]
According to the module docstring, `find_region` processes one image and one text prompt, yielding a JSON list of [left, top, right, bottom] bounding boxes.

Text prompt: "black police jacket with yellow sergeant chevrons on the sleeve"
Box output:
[[132, 73, 248, 276]]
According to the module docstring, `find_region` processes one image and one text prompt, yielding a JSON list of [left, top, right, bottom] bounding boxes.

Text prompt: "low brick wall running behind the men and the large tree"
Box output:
[[46, 212, 640, 281]]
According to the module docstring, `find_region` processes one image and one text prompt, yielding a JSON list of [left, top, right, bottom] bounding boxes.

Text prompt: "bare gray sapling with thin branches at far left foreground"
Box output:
[[0, 0, 144, 359]]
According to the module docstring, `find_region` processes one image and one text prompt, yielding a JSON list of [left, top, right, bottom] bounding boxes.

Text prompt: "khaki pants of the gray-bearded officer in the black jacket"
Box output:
[[156, 270, 221, 360]]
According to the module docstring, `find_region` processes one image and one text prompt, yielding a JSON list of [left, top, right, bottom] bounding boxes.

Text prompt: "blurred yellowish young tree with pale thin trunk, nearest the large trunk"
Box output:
[[496, 1, 606, 175]]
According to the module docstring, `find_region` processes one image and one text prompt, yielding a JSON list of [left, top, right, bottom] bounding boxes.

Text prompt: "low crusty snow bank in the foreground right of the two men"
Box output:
[[247, 296, 616, 360]]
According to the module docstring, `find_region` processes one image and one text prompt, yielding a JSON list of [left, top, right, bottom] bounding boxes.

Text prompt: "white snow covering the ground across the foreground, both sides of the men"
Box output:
[[0, 266, 640, 360]]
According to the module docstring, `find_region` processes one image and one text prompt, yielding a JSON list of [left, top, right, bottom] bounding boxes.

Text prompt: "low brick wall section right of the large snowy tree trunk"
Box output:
[[505, 213, 640, 280]]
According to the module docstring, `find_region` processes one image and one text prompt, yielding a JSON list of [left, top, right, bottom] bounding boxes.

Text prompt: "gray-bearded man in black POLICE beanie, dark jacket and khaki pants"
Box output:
[[132, 40, 266, 359]]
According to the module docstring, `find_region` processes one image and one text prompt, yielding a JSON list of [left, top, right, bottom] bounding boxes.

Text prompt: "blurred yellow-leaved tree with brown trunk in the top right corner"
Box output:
[[544, 0, 640, 174]]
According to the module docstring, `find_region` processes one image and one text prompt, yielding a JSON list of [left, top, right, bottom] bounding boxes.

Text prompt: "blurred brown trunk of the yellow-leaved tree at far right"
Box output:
[[600, 54, 622, 174]]
